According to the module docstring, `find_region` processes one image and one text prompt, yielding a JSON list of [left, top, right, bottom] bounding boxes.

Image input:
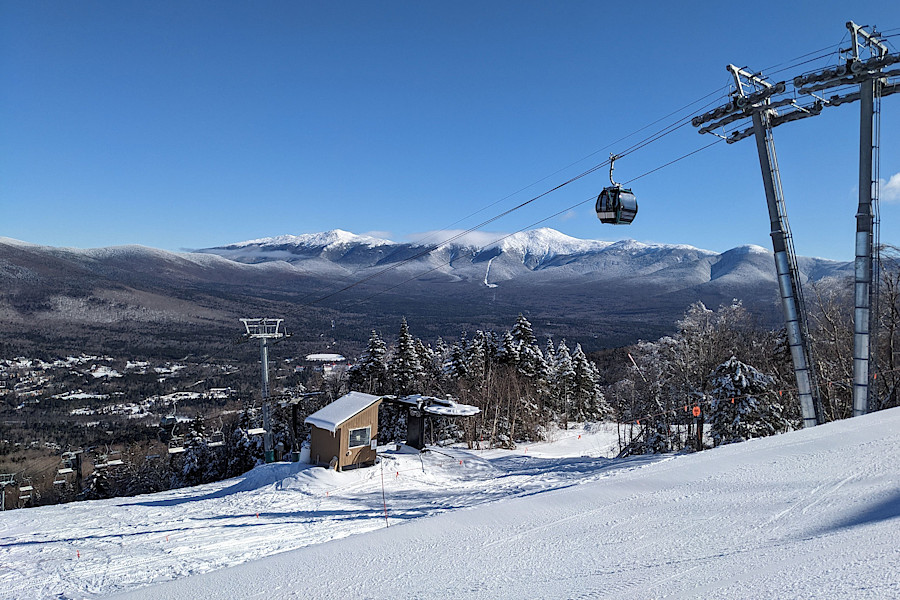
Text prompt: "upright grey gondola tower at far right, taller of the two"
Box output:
[[794, 21, 900, 416]]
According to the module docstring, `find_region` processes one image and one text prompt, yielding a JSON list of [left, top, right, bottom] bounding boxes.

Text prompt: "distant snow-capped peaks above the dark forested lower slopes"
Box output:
[[198, 228, 847, 288]]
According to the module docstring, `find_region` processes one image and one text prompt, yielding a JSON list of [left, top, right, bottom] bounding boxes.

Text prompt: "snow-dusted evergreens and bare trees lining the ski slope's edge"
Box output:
[[8, 248, 900, 508]]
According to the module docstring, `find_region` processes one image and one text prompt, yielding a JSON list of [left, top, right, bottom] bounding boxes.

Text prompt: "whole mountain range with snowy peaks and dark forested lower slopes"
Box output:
[[0, 229, 852, 353]]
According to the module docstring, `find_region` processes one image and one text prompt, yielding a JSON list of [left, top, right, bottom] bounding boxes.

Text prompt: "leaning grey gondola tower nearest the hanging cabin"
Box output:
[[692, 65, 823, 427]]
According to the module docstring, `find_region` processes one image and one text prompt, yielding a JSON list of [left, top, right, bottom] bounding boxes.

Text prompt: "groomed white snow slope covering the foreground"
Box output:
[[0, 410, 900, 599]]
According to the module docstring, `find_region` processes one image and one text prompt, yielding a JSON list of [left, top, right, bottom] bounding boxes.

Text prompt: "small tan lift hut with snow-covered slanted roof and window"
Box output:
[[304, 392, 381, 471]]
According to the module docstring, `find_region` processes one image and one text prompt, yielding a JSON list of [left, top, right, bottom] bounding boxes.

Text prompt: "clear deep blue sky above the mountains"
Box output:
[[0, 0, 900, 260]]
